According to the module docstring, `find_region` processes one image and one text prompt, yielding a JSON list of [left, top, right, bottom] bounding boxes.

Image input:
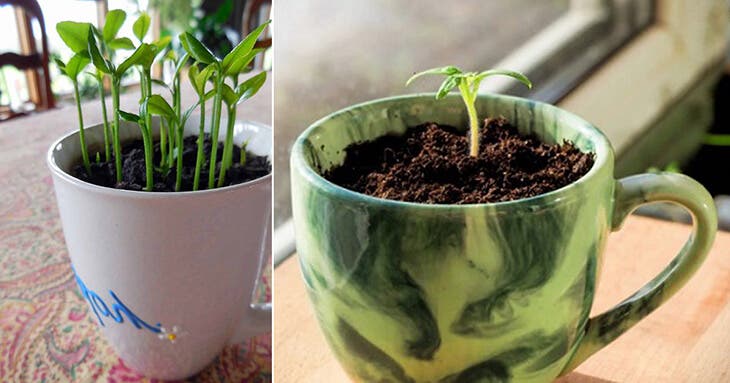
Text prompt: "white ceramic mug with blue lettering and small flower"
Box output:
[[48, 121, 271, 379]]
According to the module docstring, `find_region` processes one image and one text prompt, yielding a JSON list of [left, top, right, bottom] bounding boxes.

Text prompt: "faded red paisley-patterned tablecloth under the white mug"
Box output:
[[0, 103, 271, 383]]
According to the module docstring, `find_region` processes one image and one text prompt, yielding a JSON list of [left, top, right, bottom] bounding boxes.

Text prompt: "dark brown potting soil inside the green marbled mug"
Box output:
[[324, 118, 594, 204]]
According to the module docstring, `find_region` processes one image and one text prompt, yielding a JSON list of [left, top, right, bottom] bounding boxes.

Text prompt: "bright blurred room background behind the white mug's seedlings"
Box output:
[[0, 0, 271, 121]]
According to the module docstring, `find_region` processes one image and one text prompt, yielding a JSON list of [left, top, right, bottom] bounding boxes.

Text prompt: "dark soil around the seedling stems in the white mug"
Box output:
[[74, 134, 271, 192]]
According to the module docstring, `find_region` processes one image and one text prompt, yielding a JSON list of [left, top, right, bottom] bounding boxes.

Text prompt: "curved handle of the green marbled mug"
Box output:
[[560, 173, 717, 375]]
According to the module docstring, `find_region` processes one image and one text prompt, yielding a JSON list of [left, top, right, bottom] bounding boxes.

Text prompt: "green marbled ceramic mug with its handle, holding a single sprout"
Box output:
[[291, 95, 717, 383]]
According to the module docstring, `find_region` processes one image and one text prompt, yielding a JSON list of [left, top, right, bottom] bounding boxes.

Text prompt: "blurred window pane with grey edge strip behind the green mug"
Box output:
[[274, 0, 654, 260]]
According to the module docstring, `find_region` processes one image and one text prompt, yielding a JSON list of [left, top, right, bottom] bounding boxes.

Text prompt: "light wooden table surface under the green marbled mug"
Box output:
[[274, 216, 730, 383]]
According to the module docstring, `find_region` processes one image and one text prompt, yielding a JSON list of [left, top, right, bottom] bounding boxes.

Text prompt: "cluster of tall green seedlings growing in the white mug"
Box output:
[[56, 10, 269, 191]]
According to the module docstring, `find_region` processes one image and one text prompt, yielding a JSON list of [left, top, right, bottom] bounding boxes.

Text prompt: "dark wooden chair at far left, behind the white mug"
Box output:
[[0, 0, 56, 119]]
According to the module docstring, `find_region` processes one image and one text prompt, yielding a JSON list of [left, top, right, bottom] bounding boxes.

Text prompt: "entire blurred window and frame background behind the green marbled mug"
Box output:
[[274, 0, 730, 259]]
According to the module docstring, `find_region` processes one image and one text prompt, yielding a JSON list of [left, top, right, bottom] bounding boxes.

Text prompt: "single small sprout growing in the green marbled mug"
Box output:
[[406, 66, 532, 157]]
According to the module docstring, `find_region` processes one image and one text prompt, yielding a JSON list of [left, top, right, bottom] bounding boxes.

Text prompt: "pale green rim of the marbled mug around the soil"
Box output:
[[290, 93, 614, 210]]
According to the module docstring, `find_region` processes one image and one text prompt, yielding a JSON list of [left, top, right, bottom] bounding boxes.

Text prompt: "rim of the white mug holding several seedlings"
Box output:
[[46, 120, 274, 199]]
